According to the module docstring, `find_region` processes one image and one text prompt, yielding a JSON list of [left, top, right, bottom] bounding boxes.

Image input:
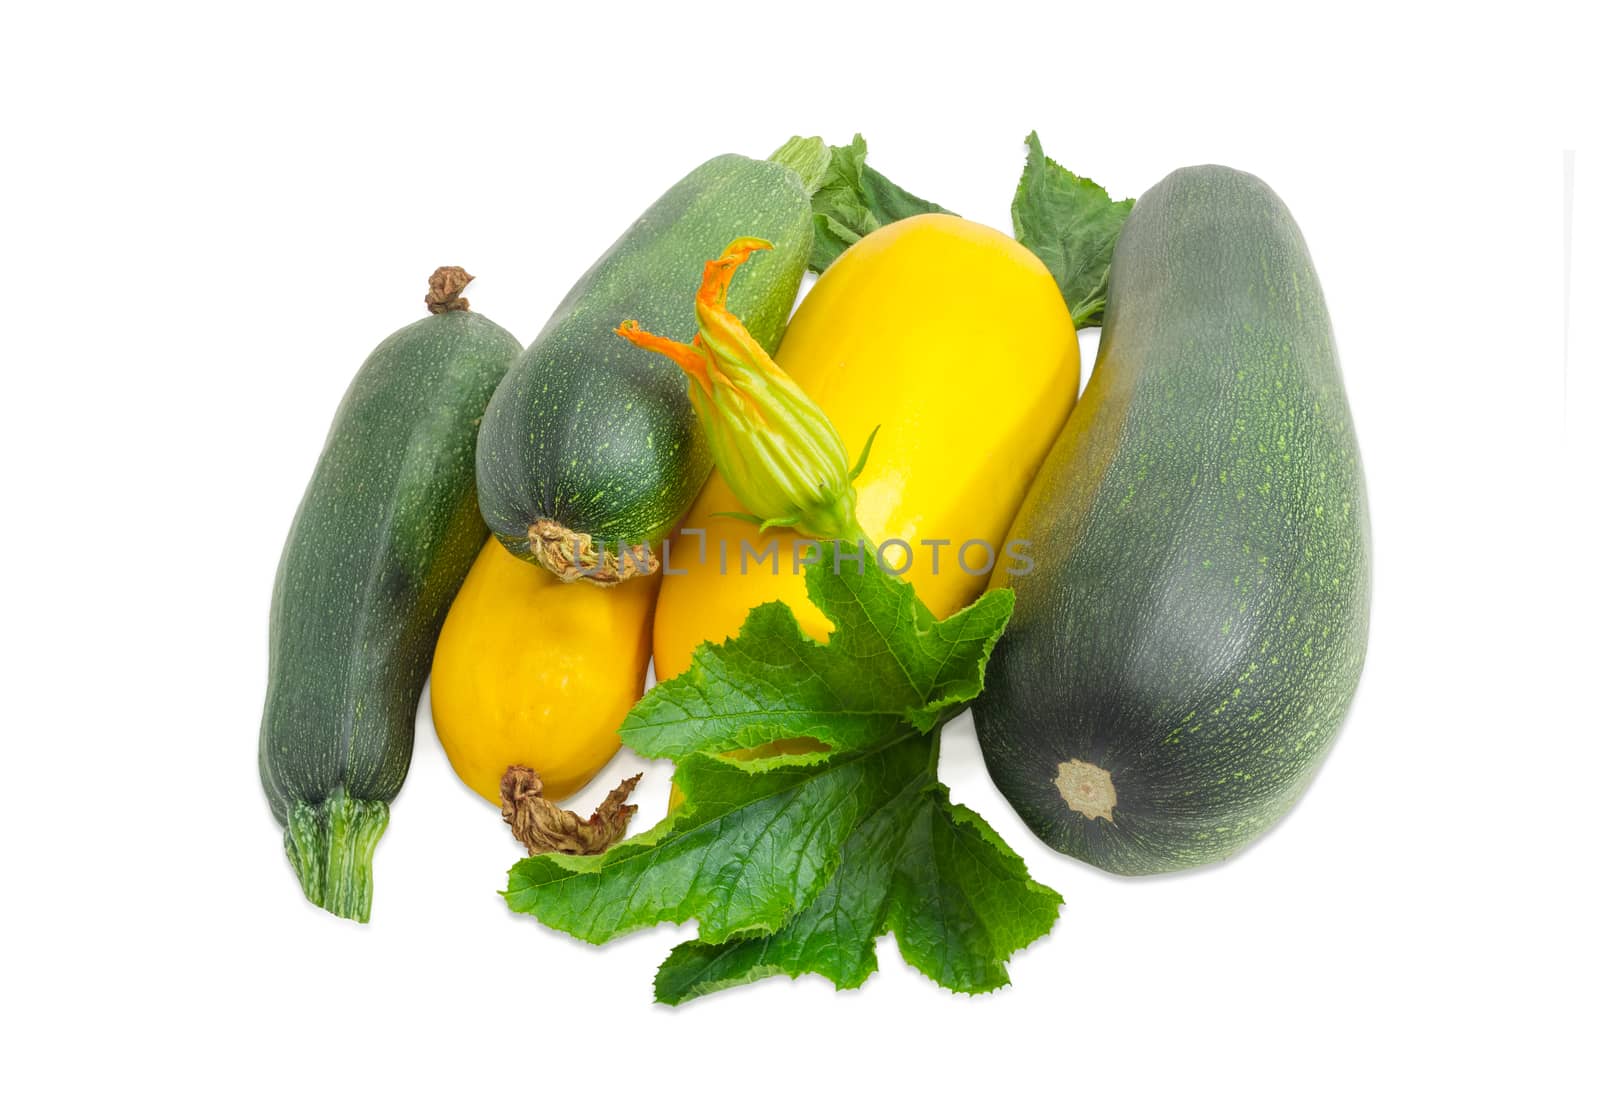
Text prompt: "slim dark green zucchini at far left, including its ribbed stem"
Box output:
[[261, 269, 522, 921]]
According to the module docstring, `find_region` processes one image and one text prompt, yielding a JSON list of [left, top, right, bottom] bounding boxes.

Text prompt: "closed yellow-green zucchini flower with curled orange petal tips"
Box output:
[[616, 238, 877, 541]]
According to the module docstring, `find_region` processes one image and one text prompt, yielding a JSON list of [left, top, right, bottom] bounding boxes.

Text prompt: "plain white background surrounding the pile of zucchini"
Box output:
[[0, 2, 1600, 1102]]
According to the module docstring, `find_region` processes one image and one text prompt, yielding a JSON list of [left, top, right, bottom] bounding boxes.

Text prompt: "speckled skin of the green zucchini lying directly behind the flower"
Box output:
[[478, 154, 811, 560]]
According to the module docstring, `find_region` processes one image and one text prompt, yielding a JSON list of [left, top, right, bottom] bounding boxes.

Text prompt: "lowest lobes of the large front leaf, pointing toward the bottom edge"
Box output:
[[656, 748, 1061, 1006]]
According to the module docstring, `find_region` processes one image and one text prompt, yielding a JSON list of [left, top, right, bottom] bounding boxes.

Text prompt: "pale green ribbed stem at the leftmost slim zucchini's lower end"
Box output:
[[283, 787, 389, 923]]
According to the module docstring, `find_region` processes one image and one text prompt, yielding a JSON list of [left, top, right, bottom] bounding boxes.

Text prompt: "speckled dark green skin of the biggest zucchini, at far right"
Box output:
[[976, 166, 1370, 875]]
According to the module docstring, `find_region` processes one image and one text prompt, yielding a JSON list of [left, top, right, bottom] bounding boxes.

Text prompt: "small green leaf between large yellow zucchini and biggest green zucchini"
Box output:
[[1011, 131, 1133, 329]]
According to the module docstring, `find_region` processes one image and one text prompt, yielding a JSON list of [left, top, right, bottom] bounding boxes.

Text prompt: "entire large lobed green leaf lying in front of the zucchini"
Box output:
[[506, 555, 1059, 1003]]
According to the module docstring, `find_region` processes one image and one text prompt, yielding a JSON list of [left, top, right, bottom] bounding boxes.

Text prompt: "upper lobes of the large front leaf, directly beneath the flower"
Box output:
[[622, 547, 1013, 760]]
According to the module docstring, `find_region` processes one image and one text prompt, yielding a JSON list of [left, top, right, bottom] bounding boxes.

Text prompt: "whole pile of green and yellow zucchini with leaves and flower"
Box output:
[[261, 134, 1370, 1004]]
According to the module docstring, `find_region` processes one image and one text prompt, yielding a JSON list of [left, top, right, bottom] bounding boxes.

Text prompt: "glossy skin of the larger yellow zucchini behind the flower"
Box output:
[[654, 214, 1078, 680]]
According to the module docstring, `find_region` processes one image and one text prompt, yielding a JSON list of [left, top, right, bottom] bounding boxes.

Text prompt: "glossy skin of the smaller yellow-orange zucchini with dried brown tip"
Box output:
[[432, 537, 659, 806]]
